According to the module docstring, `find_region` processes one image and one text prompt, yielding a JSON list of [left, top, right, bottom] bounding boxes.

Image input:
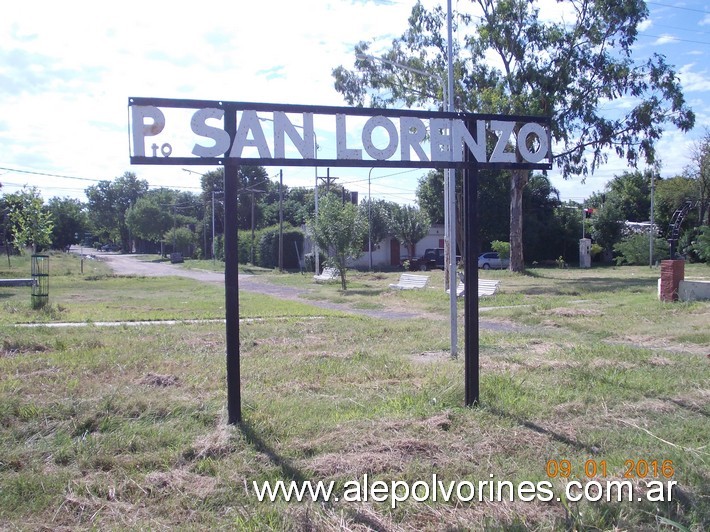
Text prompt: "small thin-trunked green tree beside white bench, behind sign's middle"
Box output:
[[309, 195, 367, 290]]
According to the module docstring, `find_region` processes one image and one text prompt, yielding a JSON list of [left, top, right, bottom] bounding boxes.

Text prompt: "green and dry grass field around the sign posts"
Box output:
[[0, 255, 710, 531]]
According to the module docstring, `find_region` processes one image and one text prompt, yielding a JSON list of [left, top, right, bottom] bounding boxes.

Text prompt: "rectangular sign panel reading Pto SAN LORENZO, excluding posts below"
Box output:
[[128, 98, 551, 170]]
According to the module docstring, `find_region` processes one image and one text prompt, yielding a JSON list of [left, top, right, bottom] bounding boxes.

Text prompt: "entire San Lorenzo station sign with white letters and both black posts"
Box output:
[[128, 98, 552, 423]]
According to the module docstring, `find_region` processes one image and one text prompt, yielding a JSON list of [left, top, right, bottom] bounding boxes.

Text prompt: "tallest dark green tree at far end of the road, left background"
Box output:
[[85, 172, 148, 250]]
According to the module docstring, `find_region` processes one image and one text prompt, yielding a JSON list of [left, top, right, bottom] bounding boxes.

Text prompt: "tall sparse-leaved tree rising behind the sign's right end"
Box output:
[[333, 0, 695, 271]]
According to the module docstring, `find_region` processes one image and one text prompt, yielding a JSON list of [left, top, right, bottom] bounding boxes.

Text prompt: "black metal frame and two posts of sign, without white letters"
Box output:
[[128, 97, 552, 424]]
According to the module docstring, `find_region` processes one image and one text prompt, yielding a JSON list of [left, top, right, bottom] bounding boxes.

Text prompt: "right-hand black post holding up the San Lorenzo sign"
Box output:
[[464, 118, 480, 406]]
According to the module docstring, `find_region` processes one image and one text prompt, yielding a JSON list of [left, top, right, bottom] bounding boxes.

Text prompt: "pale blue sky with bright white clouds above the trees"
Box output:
[[0, 0, 710, 207]]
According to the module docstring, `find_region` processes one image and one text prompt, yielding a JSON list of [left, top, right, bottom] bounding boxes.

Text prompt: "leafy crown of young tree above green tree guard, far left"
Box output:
[[5, 187, 54, 253]]
